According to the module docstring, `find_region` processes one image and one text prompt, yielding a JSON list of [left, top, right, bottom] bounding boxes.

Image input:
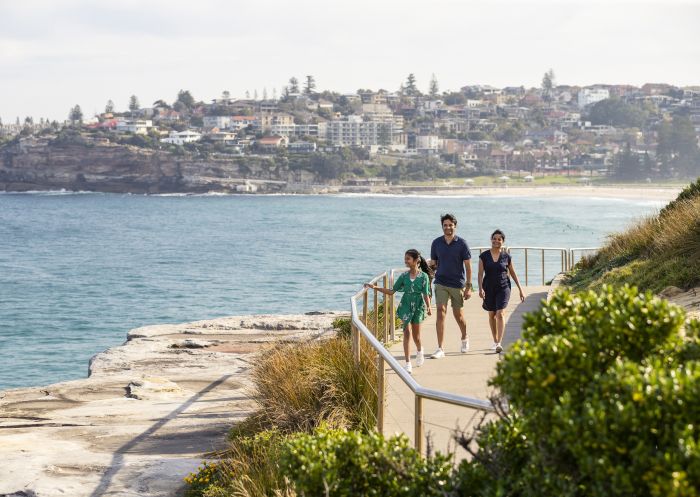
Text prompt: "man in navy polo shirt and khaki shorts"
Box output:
[[430, 214, 472, 359]]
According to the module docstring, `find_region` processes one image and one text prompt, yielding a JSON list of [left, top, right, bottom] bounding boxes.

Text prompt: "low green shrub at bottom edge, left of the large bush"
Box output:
[[280, 428, 452, 497]]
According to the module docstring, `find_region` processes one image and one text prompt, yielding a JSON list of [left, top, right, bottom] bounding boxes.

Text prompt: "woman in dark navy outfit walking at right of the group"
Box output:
[[478, 230, 525, 353]]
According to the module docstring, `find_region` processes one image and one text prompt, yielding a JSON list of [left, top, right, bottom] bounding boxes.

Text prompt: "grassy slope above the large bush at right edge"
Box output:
[[566, 180, 700, 292]]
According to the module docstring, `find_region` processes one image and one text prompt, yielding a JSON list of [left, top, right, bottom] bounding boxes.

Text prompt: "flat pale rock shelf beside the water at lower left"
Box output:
[[0, 312, 347, 497]]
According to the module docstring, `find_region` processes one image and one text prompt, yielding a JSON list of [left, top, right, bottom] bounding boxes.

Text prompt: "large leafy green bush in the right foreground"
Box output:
[[456, 286, 700, 497]]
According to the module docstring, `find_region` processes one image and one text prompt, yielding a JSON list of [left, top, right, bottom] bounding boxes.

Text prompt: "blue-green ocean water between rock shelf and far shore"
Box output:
[[0, 193, 663, 390]]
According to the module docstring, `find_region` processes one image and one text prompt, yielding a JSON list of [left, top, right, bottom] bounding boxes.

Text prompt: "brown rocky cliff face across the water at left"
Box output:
[[0, 138, 315, 193]]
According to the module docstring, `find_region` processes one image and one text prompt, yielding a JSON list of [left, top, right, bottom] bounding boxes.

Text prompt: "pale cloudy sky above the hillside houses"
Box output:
[[0, 0, 700, 123]]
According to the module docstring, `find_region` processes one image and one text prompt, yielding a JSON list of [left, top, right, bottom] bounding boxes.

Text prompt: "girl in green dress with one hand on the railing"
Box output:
[[365, 249, 433, 373]]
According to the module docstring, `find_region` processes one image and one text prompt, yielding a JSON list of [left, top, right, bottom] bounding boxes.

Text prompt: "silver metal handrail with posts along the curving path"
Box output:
[[350, 247, 598, 453]]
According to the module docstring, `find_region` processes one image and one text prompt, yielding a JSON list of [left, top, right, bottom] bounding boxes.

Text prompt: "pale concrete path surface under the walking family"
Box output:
[[384, 286, 550, 459]]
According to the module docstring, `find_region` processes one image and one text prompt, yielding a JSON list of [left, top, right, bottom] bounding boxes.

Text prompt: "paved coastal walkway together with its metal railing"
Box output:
[[350, 247, 597, 459]]
